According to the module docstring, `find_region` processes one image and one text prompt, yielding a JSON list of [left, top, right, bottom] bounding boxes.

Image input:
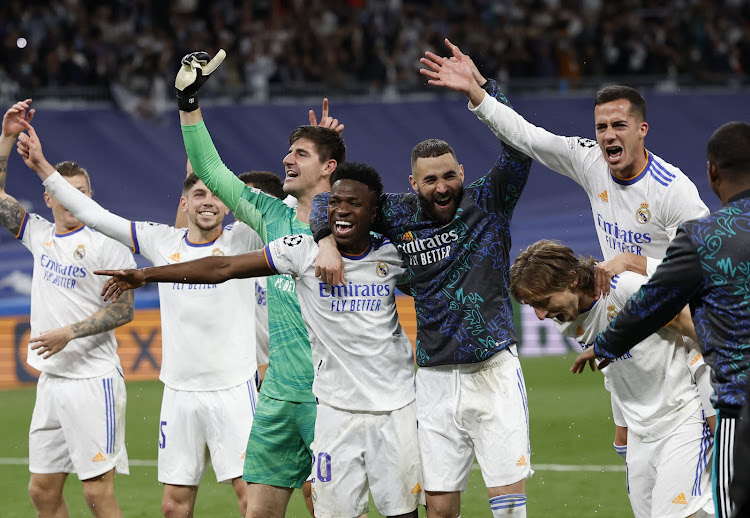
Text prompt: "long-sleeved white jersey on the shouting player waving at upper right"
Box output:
[[469, 95, 708, 274]]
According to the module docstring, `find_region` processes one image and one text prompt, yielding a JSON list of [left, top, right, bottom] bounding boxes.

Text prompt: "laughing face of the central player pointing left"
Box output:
[[328, 179, 377, 254]]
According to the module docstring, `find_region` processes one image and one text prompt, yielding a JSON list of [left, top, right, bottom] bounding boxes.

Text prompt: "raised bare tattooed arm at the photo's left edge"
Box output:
[[0, 99, 34, 236]]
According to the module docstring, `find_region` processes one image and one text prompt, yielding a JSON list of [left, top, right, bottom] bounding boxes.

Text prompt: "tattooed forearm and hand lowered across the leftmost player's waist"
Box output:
[[29, 293, 134, 360]]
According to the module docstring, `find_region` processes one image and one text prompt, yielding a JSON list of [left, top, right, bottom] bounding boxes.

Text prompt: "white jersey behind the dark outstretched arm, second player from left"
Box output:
[[132, 221, 263, 391]]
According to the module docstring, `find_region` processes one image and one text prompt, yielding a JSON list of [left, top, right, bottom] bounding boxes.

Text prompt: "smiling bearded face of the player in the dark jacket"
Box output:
[[409, 153, 464, 225]]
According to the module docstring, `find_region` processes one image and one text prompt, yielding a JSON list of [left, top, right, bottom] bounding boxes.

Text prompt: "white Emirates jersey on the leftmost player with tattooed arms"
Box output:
[[18, 213, 135, 378]]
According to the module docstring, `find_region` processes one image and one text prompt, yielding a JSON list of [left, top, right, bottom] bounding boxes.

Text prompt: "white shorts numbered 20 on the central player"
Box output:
[[313, 401, 424, 518]]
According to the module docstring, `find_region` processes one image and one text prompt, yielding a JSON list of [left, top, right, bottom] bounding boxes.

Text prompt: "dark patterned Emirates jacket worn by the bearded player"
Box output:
[[310, 82, 531, 367]]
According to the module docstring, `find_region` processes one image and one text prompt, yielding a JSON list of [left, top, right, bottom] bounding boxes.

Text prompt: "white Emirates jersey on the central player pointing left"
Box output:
[[265, 235, 415, 411]]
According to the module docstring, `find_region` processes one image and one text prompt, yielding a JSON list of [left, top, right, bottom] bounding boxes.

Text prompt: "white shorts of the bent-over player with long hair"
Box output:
[[627, 410, 713, 518]]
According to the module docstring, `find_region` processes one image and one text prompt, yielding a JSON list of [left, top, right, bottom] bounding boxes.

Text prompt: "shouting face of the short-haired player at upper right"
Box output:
[[594, 99, 648, 179]]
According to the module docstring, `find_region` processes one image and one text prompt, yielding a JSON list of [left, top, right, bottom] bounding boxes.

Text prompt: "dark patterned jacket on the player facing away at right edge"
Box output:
[[594, 191, 750, 413]]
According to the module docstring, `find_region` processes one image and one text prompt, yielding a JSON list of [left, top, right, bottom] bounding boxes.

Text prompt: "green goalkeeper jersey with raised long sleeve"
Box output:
[[182, 121, 315, 403]]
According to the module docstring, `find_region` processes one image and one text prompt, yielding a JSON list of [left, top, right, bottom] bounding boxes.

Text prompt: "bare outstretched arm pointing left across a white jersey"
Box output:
[[94, 250, 277, 300]]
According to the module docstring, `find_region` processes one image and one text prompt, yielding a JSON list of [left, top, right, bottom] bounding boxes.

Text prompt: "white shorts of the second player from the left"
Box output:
[[159, 380, 258, 486]]
